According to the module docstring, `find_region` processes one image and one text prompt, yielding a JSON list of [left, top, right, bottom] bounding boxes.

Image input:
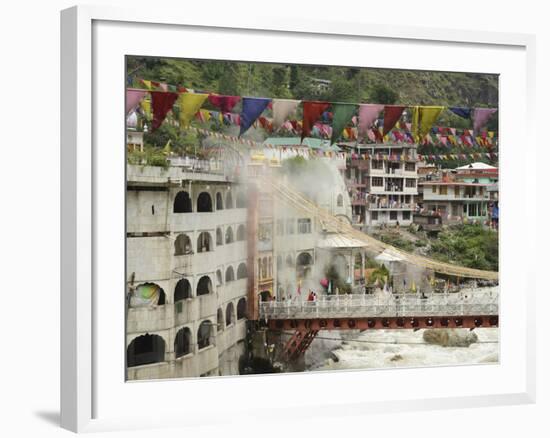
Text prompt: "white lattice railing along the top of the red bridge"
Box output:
[[260, 294, 498, 319]]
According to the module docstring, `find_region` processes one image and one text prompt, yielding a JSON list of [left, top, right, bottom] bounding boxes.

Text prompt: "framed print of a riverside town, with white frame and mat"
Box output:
[[61, 7, 536, 431]]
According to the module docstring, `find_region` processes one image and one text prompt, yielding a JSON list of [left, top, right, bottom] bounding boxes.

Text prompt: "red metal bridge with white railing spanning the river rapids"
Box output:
[[260, 288, 499, 361]]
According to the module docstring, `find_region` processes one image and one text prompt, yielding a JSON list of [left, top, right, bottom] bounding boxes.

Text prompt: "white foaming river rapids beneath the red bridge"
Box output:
[[306, 328, 499, 371]]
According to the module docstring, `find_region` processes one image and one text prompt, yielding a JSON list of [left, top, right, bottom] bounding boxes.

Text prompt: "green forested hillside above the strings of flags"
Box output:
[[127, 57, 498, 118]]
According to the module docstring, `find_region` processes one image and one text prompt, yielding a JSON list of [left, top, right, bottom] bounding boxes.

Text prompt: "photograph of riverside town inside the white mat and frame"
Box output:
[[125, 55, 500, 381]]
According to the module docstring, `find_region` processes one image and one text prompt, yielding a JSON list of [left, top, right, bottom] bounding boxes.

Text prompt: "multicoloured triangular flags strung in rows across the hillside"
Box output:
[[126, 80, 498, 148]]
